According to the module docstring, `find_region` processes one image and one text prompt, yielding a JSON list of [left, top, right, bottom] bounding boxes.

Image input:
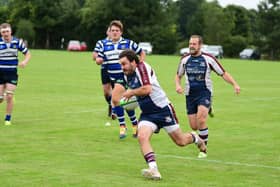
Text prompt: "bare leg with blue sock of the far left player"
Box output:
[[5, 83, 16, 125]]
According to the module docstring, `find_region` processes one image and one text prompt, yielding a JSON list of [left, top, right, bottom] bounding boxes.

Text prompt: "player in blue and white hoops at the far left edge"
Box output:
[[0, 23, 31, 125]]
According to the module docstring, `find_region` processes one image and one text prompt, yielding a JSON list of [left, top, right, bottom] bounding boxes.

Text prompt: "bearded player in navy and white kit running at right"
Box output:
[[175, 35, 240, 158]]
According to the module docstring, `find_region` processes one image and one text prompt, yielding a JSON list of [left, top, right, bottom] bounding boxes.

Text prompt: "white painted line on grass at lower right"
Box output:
[[157, 154, 280, 170]]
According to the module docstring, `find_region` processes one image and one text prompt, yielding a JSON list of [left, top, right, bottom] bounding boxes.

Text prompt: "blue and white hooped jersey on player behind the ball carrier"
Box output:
[[96, 37, 142, 74]]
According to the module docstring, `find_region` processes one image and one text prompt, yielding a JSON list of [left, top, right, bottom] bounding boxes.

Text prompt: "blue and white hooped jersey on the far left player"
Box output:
[[0, 37, 28, 71]]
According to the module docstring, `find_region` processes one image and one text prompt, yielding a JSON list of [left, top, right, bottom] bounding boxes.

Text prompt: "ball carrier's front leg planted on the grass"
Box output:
[[138, 120, 161, 180]]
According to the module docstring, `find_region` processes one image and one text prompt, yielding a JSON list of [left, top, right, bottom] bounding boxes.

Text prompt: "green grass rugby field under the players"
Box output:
[[0, 50, 280, 187]]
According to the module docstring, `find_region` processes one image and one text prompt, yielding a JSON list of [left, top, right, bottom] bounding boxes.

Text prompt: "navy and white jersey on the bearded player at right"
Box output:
[[177, 53, 225, 95]]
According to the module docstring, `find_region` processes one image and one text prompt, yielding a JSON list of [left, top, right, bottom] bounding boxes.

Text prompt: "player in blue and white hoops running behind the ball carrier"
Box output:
[[96, 20, 145, 139]]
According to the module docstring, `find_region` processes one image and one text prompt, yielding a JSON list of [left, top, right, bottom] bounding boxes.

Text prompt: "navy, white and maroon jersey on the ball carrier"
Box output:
[[125, 62, 170, 114]]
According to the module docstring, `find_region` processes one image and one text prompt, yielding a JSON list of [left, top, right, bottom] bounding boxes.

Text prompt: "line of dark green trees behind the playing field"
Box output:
[[0, 0, 280, 59]]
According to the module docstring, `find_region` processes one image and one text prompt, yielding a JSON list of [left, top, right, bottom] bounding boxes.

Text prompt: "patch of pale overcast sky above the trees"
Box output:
[[207, 0, 261, 10]]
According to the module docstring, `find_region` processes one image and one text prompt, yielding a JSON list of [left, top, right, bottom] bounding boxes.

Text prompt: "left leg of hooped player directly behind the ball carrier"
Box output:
[[112, 83, 127, 139]]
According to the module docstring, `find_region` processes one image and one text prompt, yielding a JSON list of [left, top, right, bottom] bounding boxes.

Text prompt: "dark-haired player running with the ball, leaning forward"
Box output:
[[120, 50, 206, 180]]
